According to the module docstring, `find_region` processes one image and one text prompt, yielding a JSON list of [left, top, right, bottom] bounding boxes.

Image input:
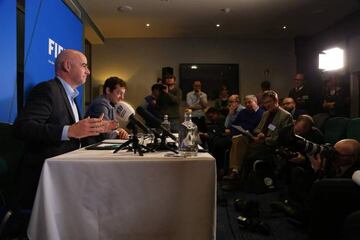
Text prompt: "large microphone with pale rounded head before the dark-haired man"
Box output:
[[115, 101, 152, 133]]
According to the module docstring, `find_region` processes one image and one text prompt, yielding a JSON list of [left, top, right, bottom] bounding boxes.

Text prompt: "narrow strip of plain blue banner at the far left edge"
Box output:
[[0, 0, 17, 123]]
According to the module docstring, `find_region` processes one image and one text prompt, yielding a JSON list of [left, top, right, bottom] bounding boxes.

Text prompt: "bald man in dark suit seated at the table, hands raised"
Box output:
[[14, 49, 115, 208]]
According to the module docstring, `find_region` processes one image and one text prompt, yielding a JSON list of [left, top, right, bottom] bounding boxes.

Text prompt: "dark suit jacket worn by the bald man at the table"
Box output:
[[14, 78, 80, 167]]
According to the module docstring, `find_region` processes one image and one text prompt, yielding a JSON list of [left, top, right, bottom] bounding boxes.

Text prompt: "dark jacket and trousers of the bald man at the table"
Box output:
[[11, 78, 80, 208]]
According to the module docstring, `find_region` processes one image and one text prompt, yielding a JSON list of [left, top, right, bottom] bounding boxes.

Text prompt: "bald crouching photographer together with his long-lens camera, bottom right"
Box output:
[[281, 121, 360, 239]]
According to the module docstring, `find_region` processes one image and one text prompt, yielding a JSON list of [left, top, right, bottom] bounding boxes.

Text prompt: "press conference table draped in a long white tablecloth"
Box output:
[[28, 142, 216, 240]]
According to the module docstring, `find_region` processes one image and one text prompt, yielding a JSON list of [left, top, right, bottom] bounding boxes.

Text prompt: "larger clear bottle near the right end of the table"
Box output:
[[179, 109, 199, 157]]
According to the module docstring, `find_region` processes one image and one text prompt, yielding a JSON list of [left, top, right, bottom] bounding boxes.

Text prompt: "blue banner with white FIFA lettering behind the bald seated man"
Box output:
[[25, 0, 83, 111]]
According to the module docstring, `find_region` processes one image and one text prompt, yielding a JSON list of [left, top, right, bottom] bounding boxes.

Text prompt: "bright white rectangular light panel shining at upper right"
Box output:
[[319, 48, 344, 71]]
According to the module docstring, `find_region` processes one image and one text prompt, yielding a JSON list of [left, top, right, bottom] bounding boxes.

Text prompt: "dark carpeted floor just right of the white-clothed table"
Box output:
[[216, 183, 307, 240]]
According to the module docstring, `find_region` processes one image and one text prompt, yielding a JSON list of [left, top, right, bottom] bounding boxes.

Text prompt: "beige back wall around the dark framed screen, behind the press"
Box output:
[[92, 38, 296, 105]]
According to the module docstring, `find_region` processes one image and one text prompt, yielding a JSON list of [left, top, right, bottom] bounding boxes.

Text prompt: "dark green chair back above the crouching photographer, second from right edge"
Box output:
[[324, 117, 349, 144]]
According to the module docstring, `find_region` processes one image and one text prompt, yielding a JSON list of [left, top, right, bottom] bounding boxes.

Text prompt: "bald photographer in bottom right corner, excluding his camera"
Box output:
[[308, 139, 360, 240]]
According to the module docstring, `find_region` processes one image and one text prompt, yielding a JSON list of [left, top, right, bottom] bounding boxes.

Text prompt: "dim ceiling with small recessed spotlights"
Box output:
[[77, 0, 359, 39]]
